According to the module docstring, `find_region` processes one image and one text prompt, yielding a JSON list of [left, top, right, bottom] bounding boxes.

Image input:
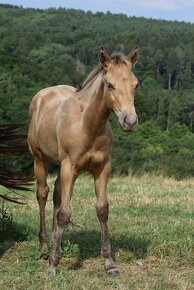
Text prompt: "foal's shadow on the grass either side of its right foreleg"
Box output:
[[65, 230, 150, 270]]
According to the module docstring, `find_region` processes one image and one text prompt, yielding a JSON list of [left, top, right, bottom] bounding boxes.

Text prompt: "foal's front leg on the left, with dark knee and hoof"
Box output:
[[48, 162, 76, 275]]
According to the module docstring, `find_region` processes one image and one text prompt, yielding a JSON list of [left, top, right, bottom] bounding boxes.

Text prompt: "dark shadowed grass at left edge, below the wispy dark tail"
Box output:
[[0, 218, 32, 257]]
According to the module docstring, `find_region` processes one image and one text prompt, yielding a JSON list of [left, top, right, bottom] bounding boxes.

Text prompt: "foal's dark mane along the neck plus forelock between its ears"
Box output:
[[76, 53, 126, 92]]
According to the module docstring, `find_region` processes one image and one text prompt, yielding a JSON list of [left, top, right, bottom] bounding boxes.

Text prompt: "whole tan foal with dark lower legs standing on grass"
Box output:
[[28, 47, 138, 276]]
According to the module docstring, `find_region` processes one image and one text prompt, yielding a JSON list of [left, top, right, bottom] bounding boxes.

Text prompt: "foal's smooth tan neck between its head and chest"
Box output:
[[82, 77, 110, 135]]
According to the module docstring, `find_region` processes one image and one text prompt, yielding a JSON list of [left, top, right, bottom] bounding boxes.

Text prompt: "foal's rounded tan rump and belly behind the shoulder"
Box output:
[[28, 86, 75, 163]]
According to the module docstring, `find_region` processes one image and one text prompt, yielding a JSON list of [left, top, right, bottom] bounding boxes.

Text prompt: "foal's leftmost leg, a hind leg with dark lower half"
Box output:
[[34, 159, 49, 253]]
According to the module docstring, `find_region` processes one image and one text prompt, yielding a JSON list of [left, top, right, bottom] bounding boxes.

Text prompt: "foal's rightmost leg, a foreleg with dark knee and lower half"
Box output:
[[94, 162, 119, 276]]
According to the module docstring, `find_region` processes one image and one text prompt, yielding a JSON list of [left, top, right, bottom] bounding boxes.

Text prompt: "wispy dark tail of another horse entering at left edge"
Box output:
[[0, 124, 34, 203]]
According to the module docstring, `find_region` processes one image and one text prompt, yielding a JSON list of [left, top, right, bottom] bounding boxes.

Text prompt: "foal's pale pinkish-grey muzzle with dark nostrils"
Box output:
[[118, 111, 138, 132]]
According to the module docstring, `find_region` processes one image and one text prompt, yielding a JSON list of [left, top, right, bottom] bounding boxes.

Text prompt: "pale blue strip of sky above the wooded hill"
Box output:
[[0, 0, 194, 23]]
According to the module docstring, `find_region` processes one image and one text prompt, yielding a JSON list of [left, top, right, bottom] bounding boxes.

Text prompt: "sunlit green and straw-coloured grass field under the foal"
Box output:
[[0, 176, 194, 290]]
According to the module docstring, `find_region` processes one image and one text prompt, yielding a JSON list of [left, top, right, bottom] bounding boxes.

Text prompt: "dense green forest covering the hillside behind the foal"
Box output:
[[0, 4, 194, 179]]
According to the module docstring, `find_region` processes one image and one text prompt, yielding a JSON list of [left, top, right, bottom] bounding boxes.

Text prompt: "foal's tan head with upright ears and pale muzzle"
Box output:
[[99, 47, 138, 132]]
